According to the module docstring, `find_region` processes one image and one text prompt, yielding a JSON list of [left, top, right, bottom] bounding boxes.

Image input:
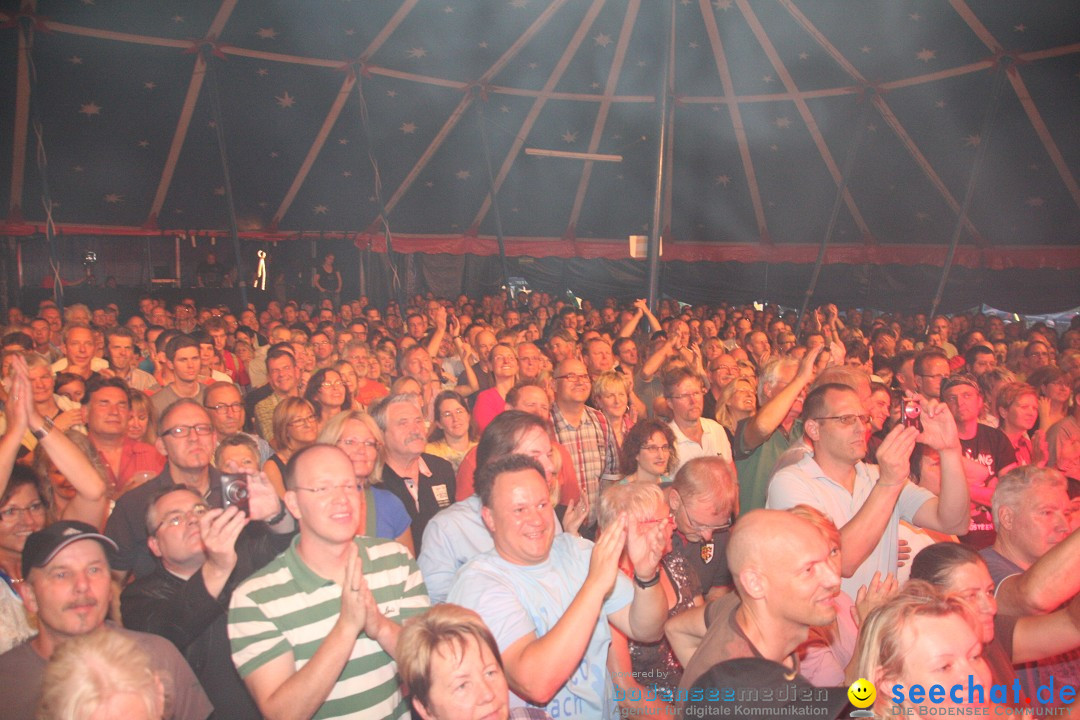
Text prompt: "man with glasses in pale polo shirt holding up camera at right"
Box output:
[[767, 382, 968, 597]]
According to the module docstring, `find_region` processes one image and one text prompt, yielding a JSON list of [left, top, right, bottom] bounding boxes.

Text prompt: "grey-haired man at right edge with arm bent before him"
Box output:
[[980, 465, 1080, 697]]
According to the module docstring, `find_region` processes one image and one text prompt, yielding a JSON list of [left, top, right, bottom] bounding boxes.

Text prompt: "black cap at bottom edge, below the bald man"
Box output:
[[679, 657, 848, 720]]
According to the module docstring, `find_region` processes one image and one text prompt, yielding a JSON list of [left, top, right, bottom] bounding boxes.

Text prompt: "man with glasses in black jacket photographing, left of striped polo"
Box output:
[[120, 476, 292, 720]]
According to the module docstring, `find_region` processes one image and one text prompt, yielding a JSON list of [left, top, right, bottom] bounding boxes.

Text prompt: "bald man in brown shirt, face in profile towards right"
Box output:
[[664, 510, 840, 690]]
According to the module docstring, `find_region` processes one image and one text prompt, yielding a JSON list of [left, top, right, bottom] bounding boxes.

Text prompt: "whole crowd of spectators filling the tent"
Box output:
[[0, 289, 1080, 720]]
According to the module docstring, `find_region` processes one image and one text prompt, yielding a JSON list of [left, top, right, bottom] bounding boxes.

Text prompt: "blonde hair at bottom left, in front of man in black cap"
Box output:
[[38, 627, 171, 720]]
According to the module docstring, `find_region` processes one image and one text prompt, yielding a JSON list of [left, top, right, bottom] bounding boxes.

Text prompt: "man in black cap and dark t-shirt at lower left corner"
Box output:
[[0, 520, 214, 720]]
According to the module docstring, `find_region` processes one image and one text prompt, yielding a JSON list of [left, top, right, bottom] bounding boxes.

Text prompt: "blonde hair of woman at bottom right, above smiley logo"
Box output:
[[855, 580, 980, 701]]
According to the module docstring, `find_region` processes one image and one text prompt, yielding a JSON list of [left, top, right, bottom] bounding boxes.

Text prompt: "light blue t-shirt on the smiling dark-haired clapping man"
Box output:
[[447, 533, 634, 720]]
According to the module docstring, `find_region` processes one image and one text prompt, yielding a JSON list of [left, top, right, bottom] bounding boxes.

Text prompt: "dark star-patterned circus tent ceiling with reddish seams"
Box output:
[[0, 0, 1080, 268]]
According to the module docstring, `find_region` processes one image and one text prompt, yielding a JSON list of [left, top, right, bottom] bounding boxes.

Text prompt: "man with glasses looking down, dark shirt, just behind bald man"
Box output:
[[666, 457, 739, 599]]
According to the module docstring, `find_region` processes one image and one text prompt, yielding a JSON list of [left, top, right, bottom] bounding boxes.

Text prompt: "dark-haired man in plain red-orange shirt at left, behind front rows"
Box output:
[[82, 378, 165, 495]]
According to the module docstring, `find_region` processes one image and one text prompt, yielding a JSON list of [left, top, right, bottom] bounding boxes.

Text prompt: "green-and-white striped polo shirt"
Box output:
[[229, 536, 430, 720]]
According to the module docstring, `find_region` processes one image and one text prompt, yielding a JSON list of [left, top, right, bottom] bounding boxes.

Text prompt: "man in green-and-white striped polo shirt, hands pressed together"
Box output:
[[229, 445, 430, 719]]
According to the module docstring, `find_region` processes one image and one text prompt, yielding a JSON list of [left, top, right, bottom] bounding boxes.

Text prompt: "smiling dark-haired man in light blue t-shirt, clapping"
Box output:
[[448, 454, 667, 719]]
